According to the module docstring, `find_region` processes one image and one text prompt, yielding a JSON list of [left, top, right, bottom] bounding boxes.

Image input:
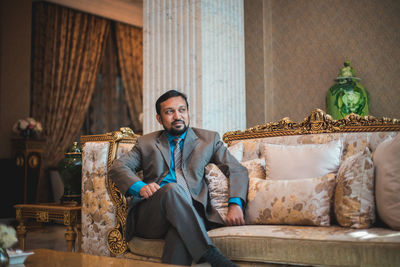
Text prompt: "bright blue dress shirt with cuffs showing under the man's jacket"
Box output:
[[128, 131, 243, 209]]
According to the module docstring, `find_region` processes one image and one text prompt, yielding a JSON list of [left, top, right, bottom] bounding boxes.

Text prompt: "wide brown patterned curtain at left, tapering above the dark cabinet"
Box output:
[[31, 2, 110, 200]]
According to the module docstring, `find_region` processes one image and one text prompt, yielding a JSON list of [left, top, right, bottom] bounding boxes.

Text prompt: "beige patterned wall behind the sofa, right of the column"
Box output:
[[245, 0, 400, 127]]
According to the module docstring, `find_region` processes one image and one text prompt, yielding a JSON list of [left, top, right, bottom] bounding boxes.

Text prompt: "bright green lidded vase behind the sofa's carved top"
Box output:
[[326, 61, 369, 120]]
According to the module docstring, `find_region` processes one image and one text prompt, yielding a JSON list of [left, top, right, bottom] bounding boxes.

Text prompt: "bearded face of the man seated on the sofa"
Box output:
[[156, 96, 190, 136]]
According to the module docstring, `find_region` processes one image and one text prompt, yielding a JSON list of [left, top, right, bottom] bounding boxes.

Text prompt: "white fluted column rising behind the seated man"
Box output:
[[143, 0, 246, 135]]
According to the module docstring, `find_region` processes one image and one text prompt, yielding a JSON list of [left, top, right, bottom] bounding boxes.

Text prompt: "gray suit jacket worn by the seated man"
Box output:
[[109, 128, 249, 237]]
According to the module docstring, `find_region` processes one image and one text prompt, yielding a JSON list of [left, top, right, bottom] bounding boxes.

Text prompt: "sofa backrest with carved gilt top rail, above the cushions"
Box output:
[[223, 109, 400, 161]]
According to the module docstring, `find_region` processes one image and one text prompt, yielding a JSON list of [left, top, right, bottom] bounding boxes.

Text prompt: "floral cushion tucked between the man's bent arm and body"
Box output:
[[205, 163, 229, 221]]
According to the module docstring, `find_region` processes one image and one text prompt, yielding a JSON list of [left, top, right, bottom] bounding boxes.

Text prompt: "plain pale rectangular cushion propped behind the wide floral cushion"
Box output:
[[262, 140, 342, 180]]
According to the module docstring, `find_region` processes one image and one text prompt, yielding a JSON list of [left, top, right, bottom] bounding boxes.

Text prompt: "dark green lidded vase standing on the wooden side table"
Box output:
[[58, 142, 82, 205]]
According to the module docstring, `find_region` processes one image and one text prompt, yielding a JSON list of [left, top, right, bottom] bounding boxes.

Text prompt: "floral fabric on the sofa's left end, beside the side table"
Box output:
[[82, 142, 133, 256]]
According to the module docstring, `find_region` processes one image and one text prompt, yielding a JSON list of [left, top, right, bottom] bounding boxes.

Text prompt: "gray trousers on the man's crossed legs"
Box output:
[[134, 183, 213, 265]]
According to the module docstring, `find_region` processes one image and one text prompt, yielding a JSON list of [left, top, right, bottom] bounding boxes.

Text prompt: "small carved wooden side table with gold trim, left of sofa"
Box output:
[[14, 203, 81, 252]]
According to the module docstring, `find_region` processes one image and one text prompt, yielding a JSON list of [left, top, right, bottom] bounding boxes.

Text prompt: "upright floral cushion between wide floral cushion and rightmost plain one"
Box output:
[[334, 147, 375, 228]]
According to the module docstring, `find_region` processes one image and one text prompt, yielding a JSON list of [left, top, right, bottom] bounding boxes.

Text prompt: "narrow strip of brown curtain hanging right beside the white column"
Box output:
[[115, 22, 143, 133]]
